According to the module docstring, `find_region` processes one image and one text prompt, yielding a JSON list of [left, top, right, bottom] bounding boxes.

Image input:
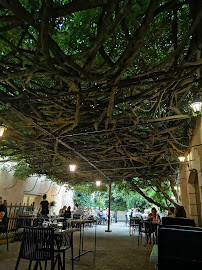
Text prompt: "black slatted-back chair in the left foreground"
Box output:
[[15, 227, 62, 270]]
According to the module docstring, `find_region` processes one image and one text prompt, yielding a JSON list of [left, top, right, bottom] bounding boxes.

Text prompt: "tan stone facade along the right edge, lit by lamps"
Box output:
[[179, 117, 202, 226]]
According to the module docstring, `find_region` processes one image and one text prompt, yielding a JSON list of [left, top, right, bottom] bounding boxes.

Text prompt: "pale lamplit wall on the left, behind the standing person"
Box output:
[[0, 160, 74, 214]]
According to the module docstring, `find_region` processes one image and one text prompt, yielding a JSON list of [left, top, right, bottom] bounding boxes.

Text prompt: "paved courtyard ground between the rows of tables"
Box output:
[[0, 222, 155, 270]]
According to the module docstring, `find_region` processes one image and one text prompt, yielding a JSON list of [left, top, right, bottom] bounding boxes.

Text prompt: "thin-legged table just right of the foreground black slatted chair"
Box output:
[[71, 219, 96, 261]]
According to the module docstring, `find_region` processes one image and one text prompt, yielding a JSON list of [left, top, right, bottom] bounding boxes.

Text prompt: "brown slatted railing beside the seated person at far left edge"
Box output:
[[5, 203, 34, 232]]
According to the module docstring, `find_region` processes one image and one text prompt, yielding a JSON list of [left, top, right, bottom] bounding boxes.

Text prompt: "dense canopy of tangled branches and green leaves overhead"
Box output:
[[0, 0, 202, 207]]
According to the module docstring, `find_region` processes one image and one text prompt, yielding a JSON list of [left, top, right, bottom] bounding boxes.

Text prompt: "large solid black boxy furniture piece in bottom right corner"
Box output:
[[158, 225, 202, 270]]
